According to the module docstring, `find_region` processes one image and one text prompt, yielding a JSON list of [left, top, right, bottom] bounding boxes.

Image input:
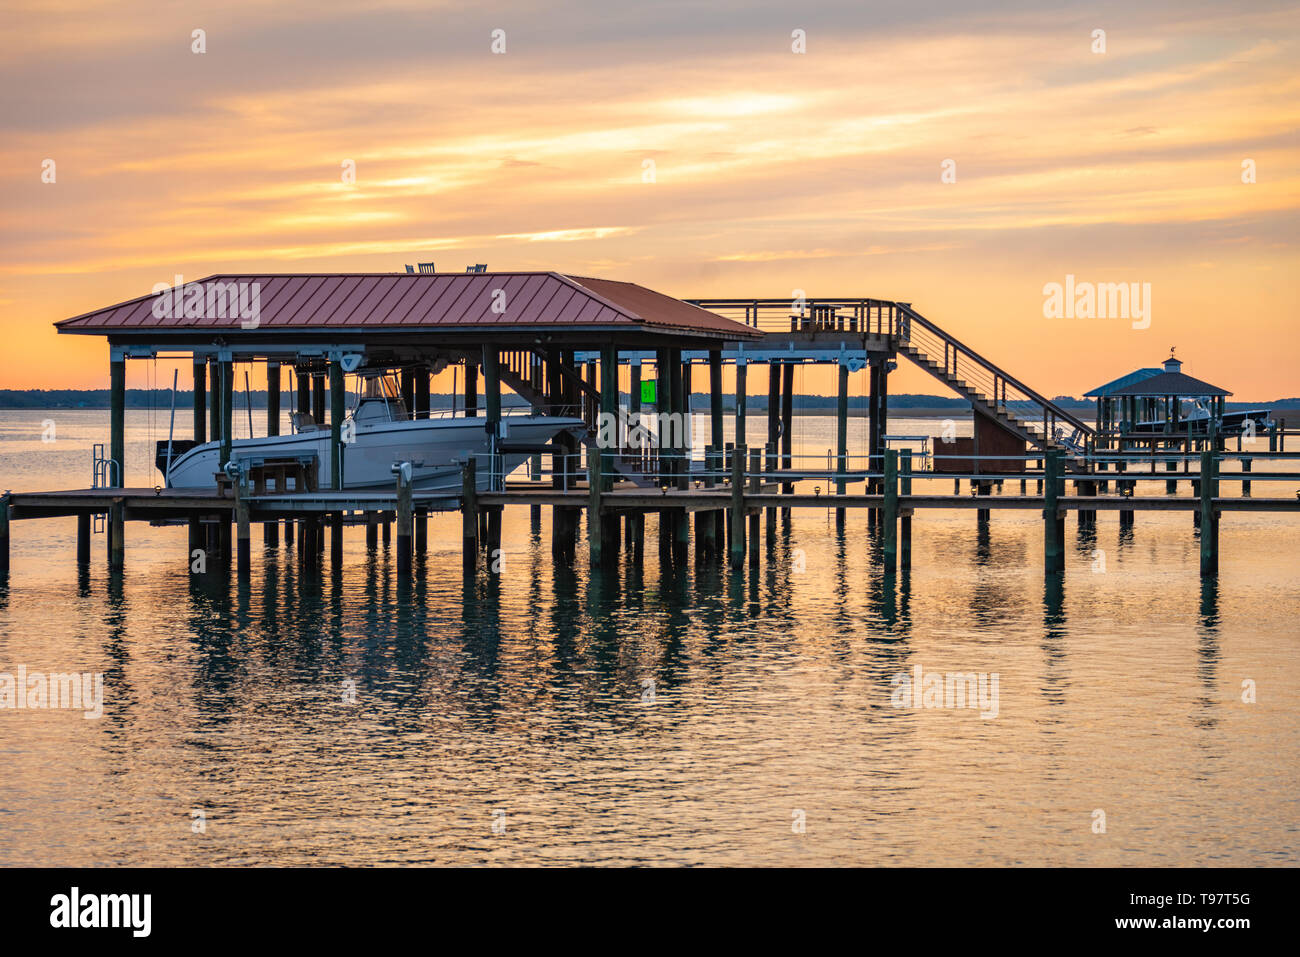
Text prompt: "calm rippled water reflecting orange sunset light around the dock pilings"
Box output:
[[0, 411, 1300, 865]]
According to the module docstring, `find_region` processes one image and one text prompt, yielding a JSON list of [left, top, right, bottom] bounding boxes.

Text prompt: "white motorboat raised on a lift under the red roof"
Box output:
[[157, 380, 585, 494]]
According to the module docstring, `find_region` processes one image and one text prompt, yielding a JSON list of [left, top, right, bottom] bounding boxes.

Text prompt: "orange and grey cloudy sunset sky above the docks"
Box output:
[[0, 0, 1300, 400]]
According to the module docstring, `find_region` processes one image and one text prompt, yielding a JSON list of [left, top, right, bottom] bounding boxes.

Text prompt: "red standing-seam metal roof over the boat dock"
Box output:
[[55, 273, 759, 339]]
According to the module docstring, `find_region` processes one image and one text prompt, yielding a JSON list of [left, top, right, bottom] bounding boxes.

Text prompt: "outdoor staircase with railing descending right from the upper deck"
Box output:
[[896, 303, 1095, 471]]
